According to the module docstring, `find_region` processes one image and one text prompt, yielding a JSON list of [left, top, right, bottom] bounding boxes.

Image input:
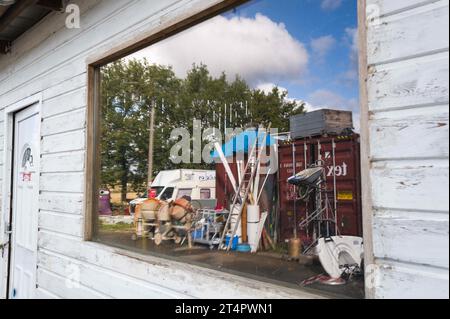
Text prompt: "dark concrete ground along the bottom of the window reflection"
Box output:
[[97, 231, 364, 299]]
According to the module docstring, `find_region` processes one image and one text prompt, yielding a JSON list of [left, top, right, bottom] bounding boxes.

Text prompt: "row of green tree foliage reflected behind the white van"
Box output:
[[101, 60, 304, 196]]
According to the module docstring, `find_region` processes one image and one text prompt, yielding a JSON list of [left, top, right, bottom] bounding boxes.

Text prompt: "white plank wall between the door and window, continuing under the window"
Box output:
[[0, 0, 317, 298]]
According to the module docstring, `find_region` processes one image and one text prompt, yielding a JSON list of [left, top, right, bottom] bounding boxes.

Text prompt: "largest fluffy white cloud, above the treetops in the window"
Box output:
[[128, 14, 308, 85]]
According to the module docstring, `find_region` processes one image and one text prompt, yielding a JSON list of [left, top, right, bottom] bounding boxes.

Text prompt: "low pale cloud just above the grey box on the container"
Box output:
[[307, 90, 360, 132]]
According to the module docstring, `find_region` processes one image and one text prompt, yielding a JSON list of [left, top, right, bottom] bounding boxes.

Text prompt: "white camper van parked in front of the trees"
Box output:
[[130, 169, 217, 215]]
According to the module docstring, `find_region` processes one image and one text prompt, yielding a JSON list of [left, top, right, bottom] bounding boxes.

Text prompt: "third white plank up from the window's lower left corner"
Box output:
[[39, 173, 84, 193]]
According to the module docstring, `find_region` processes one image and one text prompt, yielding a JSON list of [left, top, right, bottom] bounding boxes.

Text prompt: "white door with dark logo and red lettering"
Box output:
[[9, 104, 40, 299]]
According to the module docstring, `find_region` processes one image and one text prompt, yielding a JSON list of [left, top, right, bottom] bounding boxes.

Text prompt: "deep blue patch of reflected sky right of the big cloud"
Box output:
[[232, 0, 358, 99]]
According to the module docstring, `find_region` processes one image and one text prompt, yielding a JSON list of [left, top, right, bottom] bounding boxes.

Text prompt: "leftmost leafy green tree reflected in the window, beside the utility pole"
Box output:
[[101, 60, 180, 201]]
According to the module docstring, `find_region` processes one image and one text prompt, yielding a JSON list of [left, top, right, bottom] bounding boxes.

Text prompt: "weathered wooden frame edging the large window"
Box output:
[[84, 0, 374, 298]]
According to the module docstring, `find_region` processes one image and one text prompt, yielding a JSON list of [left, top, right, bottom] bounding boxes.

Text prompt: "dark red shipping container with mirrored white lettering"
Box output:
[[278, 134, 362, 241]]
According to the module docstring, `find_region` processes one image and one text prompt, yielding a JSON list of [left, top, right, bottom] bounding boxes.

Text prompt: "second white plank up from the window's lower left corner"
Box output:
[[39, 192, 83, 215]]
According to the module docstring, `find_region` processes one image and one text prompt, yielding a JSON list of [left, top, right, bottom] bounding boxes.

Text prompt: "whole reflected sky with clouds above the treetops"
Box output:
[[129, 0, 359, 129]]
